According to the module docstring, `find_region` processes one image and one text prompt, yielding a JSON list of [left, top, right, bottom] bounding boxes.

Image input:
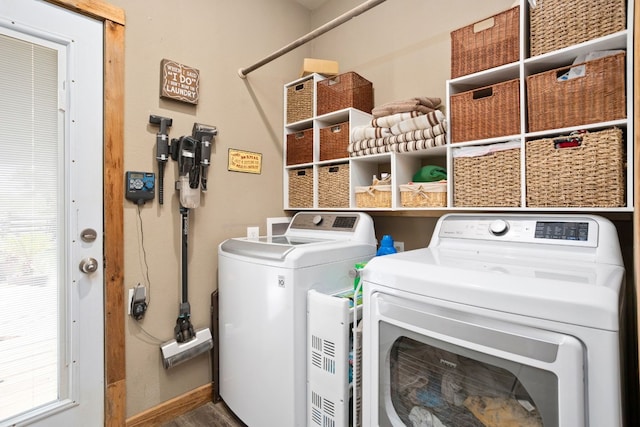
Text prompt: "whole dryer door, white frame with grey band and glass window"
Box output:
[[369, 293, 586, 427]]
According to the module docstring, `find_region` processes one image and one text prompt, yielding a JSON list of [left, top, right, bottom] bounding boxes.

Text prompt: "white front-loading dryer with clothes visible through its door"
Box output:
[[362, 214, 625, 427]]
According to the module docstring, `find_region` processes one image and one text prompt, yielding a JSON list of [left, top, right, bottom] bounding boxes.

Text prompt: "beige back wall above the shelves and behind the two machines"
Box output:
[[310, 0, 513, 249]]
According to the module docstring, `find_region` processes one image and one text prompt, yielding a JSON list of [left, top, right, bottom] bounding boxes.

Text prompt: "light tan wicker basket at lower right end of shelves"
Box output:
[[525, 128, 625, 207]]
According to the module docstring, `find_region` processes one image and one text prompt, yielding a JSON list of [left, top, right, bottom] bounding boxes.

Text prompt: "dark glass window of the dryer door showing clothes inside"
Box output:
[[389, 337, 558, 427]]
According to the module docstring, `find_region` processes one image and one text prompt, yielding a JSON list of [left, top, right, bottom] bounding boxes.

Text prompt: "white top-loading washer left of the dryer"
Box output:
[[218, 212, 377, 427]]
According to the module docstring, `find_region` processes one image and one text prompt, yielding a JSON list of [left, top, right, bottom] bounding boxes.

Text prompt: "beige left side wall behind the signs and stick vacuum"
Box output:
[[111, 0, 310, 417]]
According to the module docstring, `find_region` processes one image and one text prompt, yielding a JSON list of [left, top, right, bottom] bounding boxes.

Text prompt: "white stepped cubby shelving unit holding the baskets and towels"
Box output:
[[284, 0, 634, 212]]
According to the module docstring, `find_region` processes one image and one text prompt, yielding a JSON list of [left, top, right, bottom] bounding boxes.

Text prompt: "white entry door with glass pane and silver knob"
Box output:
[[0, 0, 104, 426]]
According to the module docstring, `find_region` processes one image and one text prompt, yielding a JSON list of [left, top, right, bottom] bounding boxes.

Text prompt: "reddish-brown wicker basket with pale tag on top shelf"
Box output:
[[451, 6, 520, 78]]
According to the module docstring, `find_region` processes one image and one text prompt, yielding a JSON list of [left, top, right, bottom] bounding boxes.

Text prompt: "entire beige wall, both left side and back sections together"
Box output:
[[111, 0, 510, 417]]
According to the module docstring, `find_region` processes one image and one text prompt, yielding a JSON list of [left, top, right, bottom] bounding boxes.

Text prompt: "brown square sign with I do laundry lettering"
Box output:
[[160, 59, 200, 104]]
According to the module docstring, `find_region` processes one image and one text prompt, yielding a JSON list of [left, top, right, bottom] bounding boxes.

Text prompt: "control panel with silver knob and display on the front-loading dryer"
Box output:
[[438, 215, 598, 247]]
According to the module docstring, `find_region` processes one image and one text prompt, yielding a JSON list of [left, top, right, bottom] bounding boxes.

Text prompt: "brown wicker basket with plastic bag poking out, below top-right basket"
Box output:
[[527, 52, 626, 132]]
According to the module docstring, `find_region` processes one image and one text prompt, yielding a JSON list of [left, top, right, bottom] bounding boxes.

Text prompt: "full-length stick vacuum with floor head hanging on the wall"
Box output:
[[160, 123, 218, 369]]
